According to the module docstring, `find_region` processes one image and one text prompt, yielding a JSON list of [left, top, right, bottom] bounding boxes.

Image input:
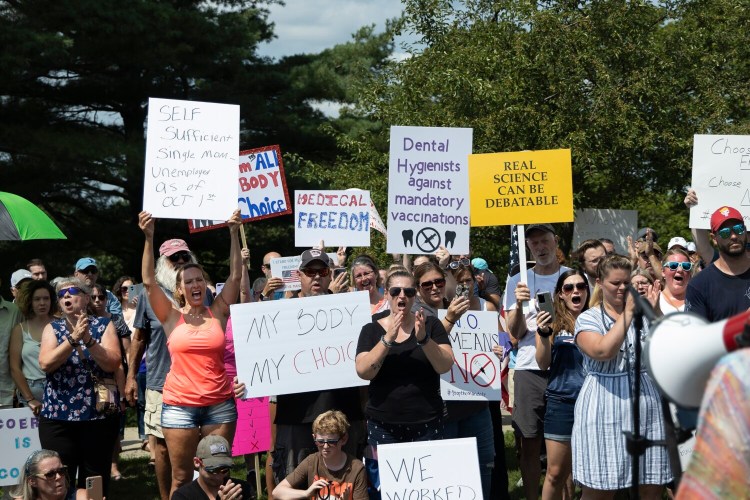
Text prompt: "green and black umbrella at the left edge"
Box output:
[[0, 191, 67, 241]]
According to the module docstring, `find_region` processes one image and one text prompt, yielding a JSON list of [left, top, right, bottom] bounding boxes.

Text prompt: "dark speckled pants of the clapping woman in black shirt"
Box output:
[[365, 418, 444, 500]]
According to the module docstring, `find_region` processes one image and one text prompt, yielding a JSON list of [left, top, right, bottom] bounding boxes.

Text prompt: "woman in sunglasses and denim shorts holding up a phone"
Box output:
[[536, 269, 590, 500]]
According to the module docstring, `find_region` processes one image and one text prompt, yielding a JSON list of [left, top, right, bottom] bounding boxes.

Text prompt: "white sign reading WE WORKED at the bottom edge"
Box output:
[[378, 438, 482, 500]]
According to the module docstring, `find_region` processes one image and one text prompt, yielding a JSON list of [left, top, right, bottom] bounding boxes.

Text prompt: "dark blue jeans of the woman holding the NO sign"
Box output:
[[443, 408, 495, 500]]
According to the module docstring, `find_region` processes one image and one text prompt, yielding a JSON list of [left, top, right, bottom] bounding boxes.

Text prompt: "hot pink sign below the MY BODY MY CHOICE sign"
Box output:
[[232, 398, 271, 457]]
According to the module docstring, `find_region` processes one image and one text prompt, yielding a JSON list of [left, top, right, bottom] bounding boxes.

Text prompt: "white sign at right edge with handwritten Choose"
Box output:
[[690, 135, 750, 229]]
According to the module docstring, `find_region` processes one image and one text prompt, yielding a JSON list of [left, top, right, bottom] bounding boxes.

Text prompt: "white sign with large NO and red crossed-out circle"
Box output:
[[438, 309, 502, 401]]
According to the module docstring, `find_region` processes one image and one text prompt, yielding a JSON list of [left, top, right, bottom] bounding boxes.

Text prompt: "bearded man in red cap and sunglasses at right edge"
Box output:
[[685, 207, 750, 323]]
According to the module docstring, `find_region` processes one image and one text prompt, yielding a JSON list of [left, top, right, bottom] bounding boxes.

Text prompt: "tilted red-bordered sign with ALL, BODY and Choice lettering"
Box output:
[[188, 145, 292, 233]]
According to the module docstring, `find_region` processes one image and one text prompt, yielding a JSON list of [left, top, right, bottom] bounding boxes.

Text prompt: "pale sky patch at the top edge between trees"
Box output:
[[259, 0, 412, 58]]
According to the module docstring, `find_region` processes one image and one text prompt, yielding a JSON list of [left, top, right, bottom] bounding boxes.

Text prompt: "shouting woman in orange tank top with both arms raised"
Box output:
[[138, 210, 242, 496]]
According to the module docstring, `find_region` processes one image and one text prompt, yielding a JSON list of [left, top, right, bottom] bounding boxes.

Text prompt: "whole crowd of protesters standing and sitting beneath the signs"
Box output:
[[0, 190, 750, 500]]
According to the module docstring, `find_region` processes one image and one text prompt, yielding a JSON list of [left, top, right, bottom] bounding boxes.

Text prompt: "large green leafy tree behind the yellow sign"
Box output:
[[300, 0, 750, 270]]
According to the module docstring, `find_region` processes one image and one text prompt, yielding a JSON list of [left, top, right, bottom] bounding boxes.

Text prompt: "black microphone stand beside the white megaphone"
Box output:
[[624, 285, 671, 499]]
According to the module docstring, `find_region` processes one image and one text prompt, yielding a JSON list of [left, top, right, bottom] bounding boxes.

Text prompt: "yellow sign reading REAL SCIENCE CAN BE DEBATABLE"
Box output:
[[469, 149, 573, 226]]
